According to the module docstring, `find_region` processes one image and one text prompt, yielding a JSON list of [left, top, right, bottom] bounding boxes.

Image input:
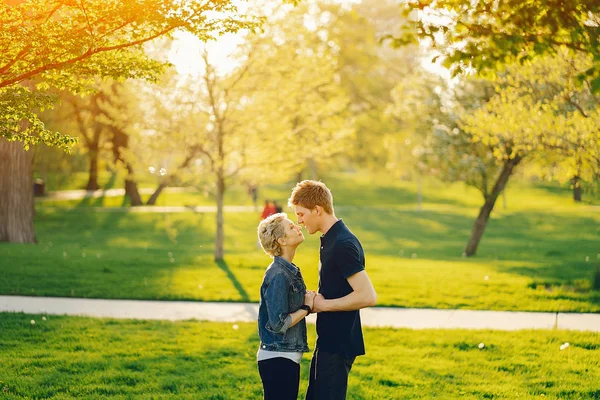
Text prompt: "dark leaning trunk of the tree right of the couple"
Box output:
[[464, 156, 523, 257]]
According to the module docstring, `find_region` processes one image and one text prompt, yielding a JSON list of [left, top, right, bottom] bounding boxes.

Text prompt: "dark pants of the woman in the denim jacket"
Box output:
[[258, 357, 300, 400]]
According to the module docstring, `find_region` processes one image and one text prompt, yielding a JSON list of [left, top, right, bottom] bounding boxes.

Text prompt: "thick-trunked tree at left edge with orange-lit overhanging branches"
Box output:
[[0, 0, 259, 243]]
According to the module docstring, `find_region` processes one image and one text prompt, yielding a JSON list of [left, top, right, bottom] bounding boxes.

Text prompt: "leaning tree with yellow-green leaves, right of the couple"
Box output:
[[459, 54, 600, 256]]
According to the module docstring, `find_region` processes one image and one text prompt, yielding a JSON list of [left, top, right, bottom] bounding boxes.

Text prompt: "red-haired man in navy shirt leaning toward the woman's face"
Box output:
[[288, 180, 377, 400]]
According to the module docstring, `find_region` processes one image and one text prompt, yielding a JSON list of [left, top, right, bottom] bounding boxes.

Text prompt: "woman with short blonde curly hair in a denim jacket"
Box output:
[[257, 213, 315, 400]]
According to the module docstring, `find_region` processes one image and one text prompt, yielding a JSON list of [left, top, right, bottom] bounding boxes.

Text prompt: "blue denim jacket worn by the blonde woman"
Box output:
[[258, 256, 308, 352]]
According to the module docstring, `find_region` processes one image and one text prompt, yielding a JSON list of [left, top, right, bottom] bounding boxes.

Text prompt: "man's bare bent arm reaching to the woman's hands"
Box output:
[[313, 270, 377, 312]]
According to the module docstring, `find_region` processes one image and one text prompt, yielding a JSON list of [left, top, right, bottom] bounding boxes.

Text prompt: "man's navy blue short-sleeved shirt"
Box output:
[[316, 219, 365, 358]]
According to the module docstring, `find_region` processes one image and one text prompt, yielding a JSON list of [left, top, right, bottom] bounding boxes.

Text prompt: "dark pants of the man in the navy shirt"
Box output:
[[306, 349, 355, 400]]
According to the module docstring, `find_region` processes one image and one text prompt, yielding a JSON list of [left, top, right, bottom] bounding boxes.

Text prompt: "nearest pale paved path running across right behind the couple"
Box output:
[[0, 296, 600, 332]]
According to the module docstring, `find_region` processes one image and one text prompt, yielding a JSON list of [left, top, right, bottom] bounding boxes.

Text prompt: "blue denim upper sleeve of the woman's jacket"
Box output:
[[265, 273, 292, 334]]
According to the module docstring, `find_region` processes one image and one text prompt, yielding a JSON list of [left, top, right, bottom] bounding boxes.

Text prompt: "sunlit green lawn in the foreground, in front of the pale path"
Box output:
[[0, 314, 600, 400]]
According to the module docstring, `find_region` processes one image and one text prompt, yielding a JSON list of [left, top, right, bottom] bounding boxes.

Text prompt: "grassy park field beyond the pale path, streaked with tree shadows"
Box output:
[[0, 174, 600, 312]]
